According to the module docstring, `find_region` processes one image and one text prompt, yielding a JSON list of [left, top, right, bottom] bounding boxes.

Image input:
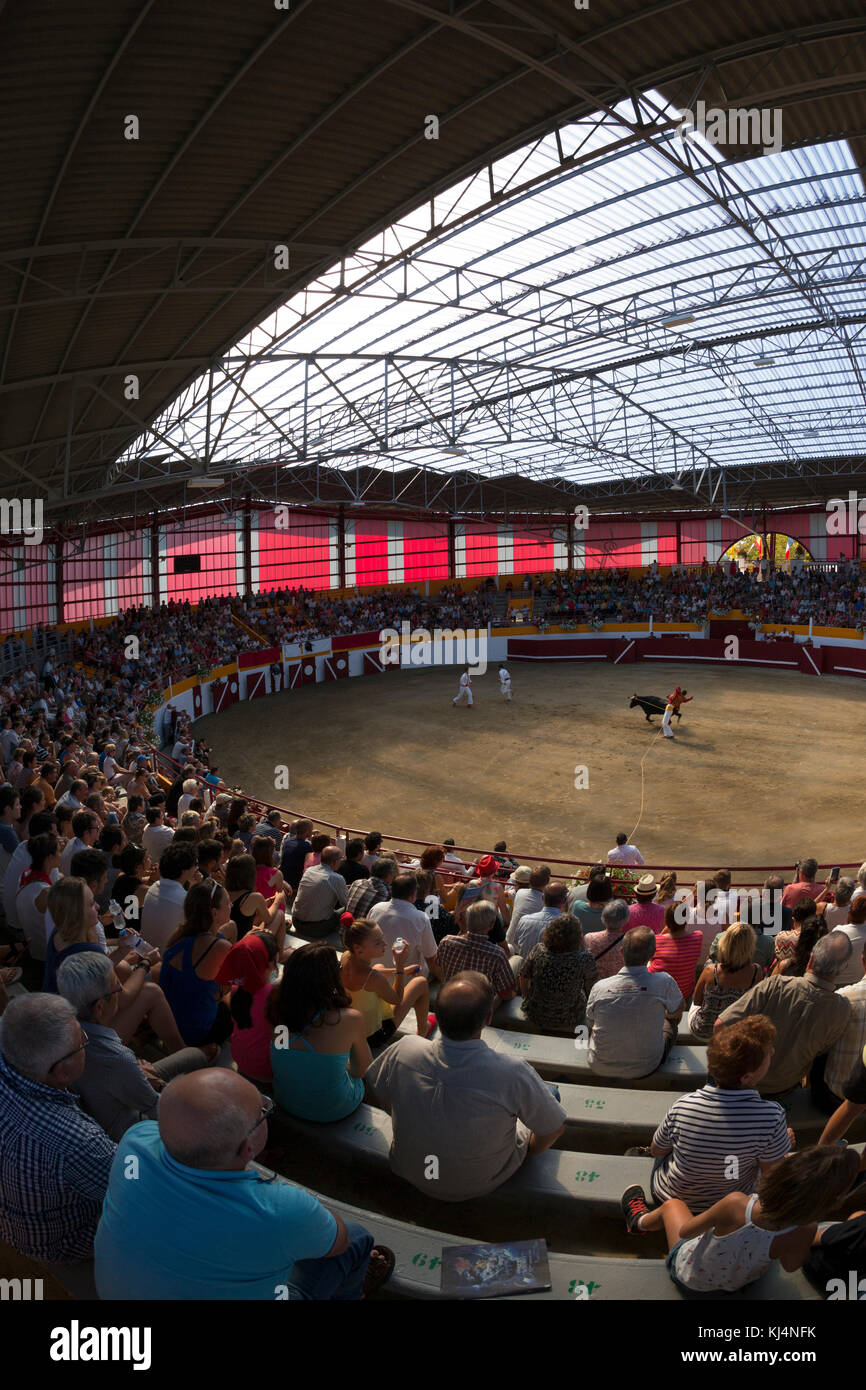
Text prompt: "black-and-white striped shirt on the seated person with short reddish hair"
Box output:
[[652, 1086, 791, 1216]]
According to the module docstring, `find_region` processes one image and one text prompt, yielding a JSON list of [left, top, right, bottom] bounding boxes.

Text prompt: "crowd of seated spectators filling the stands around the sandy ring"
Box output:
[[0, 558, 866, 1298]]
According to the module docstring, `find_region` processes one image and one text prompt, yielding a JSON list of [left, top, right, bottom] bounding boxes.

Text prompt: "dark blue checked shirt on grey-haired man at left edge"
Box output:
[[0, 1055, 114, 1264]]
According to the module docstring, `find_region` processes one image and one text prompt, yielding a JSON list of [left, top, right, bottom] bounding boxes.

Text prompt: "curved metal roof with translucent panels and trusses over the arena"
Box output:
[[0, 0, 866, 514]]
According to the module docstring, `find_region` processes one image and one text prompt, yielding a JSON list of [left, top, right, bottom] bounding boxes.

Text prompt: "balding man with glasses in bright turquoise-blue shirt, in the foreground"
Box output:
[[95, 1068, 393, 1300]]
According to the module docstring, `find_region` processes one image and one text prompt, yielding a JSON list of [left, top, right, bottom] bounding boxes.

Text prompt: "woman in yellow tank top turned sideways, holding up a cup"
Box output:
[[341, 917, 436, 1043]]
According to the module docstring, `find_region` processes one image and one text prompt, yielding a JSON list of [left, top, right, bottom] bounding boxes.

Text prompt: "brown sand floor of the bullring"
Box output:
[[196, 662, 866, 869]]
